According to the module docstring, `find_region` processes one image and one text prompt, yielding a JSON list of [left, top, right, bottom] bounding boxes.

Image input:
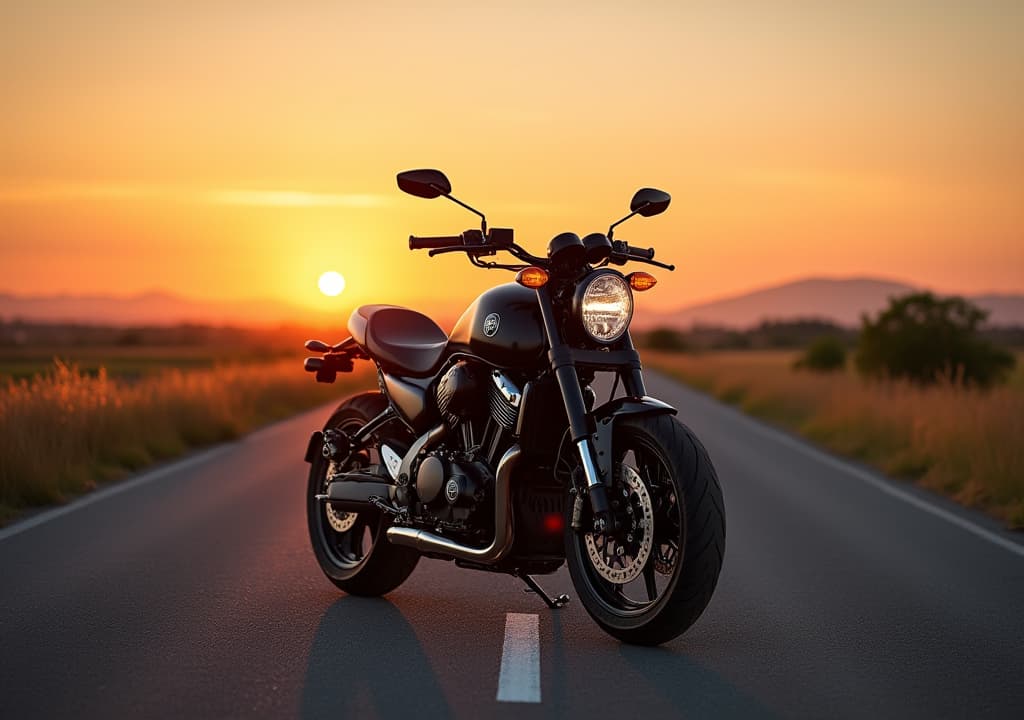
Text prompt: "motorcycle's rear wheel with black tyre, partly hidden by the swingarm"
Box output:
[[306, 392, 420, 595]]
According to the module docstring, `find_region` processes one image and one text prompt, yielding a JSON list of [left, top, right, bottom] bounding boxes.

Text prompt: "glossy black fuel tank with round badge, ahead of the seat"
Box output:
[[449, 283, 546, 369]]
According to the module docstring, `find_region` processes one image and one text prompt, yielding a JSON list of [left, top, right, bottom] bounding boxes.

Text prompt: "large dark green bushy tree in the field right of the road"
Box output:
[[857, 293, 1014, 386]]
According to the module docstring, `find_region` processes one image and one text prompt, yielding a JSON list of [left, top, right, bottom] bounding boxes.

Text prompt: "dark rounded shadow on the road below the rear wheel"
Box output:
[[300, 595, 452, 718]]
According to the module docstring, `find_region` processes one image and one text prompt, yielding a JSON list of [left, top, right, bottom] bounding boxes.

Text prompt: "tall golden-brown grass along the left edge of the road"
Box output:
[[0, 359, 373, 524]]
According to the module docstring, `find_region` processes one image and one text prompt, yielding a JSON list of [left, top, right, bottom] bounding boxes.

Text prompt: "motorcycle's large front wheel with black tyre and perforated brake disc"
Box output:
[[565, 415, 725, 645]]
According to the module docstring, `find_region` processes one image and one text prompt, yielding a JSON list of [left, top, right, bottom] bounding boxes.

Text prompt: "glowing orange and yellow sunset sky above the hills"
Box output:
[[0, 0, 1024, 321]]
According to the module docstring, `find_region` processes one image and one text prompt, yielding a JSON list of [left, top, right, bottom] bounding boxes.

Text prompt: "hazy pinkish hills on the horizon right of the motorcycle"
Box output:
[[638, 278, 1024, 328]]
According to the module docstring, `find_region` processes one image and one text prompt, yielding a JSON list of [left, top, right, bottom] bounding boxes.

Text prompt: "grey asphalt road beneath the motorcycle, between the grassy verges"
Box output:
[[0, 374, 1024, 718]]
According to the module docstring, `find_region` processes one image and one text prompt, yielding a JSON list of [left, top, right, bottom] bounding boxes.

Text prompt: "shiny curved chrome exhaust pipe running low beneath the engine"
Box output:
[[387, 444, 521, 564]]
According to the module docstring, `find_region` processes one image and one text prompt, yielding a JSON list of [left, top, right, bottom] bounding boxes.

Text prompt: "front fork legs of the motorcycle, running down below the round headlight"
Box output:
[[537, 286, 647, 533]]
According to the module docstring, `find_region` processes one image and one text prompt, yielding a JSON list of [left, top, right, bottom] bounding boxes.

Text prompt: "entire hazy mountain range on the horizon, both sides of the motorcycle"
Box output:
[[0, 278, 1024, 328]]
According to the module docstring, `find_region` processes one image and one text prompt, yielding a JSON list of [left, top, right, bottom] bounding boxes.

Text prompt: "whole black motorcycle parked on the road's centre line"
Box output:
[[305, 170, 725, 645]]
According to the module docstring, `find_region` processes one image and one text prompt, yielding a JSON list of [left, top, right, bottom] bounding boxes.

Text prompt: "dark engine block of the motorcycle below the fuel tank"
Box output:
[[407, 361, 521, 537]]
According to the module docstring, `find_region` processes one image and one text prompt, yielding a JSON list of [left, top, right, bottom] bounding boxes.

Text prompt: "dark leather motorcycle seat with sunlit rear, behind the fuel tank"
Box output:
[[348, 305, 447, 377]]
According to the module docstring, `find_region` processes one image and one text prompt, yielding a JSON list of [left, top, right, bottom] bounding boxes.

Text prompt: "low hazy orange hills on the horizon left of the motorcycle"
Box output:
[[0, 292, 331, 327]]
